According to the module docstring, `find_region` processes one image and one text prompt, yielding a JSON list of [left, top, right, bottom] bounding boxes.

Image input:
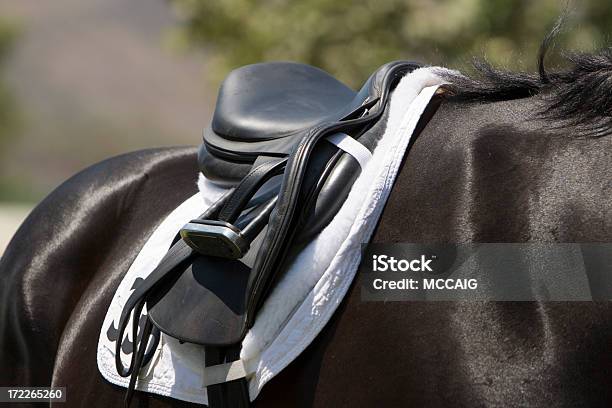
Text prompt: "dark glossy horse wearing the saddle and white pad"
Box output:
[[0, 39, 612, 407]]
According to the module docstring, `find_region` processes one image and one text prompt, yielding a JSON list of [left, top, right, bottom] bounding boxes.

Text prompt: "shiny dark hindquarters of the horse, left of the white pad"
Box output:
[[0, 148, 197, 398]]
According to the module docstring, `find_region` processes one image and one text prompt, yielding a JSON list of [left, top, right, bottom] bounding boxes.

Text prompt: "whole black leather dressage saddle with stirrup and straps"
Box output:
[[115, 61, 419, 407]]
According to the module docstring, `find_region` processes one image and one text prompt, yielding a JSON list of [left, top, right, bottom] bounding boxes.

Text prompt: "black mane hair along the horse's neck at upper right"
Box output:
[[447, 21, 612, 136]]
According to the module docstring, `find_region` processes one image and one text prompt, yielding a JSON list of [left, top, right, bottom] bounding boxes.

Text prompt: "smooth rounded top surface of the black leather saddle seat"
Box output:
[[212, 62, 355, 142]]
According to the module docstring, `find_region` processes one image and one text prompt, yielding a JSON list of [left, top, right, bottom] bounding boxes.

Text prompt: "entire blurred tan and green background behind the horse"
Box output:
[[0, 0, 612, 248]]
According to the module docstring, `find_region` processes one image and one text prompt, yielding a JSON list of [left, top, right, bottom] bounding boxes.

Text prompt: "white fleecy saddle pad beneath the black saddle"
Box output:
[[97, 68, 444, 404]]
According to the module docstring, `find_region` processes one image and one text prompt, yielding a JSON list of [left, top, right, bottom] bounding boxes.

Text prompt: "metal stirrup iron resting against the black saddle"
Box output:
[[180, 220, 250, 259]]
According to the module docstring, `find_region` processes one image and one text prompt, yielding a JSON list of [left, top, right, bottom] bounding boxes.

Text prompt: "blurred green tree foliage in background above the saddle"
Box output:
[[173, 0, 612, 86]]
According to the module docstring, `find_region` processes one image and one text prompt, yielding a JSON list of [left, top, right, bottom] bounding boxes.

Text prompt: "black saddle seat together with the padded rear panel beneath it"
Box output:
[[198, 62, 375, 186]]
